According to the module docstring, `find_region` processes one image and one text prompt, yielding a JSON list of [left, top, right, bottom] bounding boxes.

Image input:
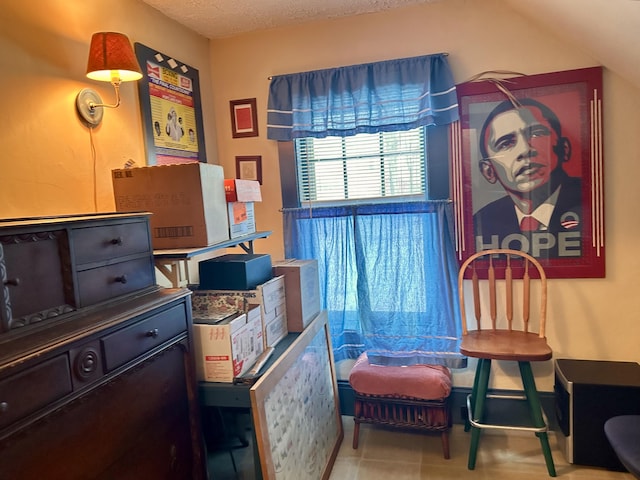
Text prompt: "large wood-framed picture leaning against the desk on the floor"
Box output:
[[250, 311, 344, 480]]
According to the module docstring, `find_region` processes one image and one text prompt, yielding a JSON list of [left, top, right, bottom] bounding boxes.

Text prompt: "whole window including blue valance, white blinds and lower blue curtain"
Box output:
[[267, 54, 463, 366]]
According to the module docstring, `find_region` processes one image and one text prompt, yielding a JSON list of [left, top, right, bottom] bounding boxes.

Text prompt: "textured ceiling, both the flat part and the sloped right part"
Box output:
[[143, 0, 640, 88]]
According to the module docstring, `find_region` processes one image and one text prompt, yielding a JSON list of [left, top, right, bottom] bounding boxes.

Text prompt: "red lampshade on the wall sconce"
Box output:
[[87, 32, 142, 82]]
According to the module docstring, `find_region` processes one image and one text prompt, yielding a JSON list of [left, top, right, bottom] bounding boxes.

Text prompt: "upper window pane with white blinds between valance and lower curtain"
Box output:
[[295, 127, 426, 203]]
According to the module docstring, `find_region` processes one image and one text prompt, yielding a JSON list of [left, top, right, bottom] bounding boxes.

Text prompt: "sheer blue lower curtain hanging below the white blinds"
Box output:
[[284, 202, 465, 368]]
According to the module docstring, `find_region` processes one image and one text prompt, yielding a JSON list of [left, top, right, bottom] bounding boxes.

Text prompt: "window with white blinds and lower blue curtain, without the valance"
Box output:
[[279, 126, 463, 368]]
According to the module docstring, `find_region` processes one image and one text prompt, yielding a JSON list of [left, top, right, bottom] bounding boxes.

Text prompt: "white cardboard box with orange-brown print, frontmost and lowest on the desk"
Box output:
[[193, 307, 264, 383]]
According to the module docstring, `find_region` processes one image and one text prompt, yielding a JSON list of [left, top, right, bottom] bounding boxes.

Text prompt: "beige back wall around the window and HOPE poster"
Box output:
[[211, 0, 640, 391]]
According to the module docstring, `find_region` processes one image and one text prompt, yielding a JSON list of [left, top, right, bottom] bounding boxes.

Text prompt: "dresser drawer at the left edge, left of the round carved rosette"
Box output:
[[0, 354, 72, 428]]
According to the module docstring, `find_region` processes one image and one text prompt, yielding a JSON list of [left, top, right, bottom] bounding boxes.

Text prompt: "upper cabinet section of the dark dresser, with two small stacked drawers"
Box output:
[[0, 213, 155, 333]]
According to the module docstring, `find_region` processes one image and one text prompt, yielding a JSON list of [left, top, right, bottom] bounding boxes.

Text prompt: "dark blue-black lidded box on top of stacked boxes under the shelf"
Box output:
[[198, 253, 273, 290]]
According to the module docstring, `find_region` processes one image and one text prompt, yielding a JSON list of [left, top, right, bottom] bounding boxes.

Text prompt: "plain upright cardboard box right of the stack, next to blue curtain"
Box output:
[[273, 260, 320, 332]]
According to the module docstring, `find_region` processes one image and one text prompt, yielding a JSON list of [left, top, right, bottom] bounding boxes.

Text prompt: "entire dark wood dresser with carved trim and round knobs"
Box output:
[[0, 214, 207, 480]]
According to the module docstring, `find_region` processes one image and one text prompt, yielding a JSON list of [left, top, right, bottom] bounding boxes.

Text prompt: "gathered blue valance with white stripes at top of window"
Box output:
[[267, 54, 458, 141]]
